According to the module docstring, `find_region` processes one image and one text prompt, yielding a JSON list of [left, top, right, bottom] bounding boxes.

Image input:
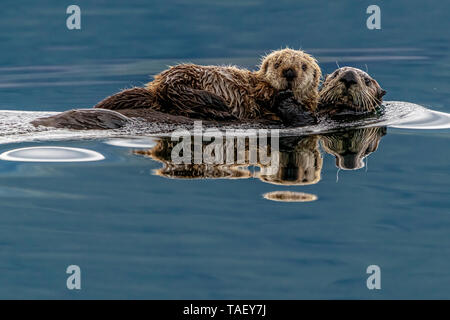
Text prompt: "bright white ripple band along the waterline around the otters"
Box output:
[[0, 101, 450, 147]]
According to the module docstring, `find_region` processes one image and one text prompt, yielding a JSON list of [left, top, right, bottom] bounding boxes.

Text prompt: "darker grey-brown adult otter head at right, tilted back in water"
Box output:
[[319, 67, 386, 112]]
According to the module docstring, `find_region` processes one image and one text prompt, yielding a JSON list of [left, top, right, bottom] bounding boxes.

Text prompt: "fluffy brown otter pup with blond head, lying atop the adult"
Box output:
[[95, 49, 321, 120]]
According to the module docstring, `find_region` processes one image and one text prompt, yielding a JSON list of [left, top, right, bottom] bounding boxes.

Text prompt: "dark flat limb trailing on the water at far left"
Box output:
[[31, 109, 130, 130]]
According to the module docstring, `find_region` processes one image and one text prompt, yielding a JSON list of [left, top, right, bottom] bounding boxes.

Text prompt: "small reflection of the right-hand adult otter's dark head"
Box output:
[[321, 127, 386, 170]]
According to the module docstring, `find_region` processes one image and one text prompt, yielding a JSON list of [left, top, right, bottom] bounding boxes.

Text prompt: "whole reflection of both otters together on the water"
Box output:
[[134, 127, 386, 189]]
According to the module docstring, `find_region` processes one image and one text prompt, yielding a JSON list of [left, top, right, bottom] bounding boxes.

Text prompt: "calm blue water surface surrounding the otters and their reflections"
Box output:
[[0, 0, 450, 299]]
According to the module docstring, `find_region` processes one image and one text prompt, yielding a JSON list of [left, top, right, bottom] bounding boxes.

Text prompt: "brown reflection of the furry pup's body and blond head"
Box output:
[[134, 136, 323, 185]]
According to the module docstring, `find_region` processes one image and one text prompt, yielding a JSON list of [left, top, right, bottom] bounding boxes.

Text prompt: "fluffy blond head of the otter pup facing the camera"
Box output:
[[257, 49, 322, 111]]
